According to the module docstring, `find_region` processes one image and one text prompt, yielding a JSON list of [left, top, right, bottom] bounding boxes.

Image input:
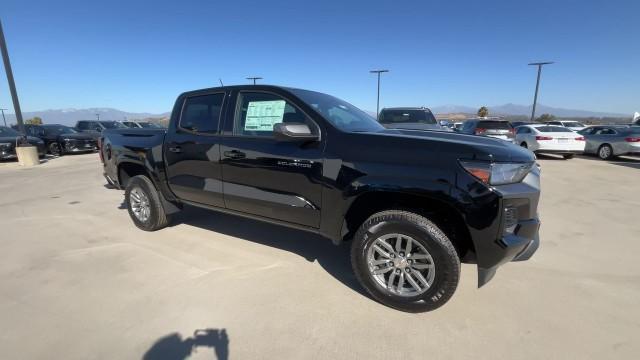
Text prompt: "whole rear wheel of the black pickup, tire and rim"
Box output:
[[124, 175, 169, 231]]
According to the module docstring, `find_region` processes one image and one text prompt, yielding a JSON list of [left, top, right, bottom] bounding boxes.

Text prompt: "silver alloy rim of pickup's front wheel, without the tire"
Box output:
[[367, 234, 436, 297]]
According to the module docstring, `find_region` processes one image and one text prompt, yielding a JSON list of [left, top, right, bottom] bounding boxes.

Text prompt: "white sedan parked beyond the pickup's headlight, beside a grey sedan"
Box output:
[[515, 124, 585, 159]]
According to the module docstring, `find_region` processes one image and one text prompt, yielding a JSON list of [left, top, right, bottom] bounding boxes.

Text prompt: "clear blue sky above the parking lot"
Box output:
[[0, 0, 640, 113]]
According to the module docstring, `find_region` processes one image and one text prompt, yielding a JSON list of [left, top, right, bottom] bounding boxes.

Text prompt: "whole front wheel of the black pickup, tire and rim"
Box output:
[[351, 210, 460, 312]]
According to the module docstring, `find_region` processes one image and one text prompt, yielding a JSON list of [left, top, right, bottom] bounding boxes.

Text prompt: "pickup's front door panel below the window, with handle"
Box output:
[[222, 137, 322, 227]]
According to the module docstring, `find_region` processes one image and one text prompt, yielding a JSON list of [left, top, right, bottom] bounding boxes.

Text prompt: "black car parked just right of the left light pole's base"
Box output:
[[24, 124, 97, 156]]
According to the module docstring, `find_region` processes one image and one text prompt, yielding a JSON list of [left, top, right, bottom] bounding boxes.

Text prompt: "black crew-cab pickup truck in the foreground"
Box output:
[[101, 85, 540, 312]]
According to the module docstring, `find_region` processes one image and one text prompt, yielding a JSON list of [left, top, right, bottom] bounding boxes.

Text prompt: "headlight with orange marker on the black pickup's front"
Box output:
[[460, 161, 534, 185]]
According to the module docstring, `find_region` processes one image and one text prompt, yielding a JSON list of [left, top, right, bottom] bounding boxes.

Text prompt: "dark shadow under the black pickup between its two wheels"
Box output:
[[171, 206, 366, 296]]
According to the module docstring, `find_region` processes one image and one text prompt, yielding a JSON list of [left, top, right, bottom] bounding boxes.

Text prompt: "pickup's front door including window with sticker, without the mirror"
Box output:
[[220, 91, 323, 228]]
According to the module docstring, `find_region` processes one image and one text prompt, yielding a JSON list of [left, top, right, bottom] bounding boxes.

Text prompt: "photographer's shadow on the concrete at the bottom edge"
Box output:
[[142, 329, 229, 360]]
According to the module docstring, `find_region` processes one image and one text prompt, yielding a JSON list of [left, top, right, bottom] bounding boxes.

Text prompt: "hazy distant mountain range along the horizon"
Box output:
[[0, 104, 631, 125]]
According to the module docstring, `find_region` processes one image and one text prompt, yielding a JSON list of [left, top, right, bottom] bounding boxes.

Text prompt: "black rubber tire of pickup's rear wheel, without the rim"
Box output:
[[124, 175, 170, 231]]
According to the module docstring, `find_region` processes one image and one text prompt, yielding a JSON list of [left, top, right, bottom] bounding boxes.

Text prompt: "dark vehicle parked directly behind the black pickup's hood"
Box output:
[[378, 107, 451, 131]]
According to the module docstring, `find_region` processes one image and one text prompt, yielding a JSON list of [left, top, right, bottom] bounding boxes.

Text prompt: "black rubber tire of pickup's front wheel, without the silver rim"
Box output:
[[351, 210, 460, 313]]
